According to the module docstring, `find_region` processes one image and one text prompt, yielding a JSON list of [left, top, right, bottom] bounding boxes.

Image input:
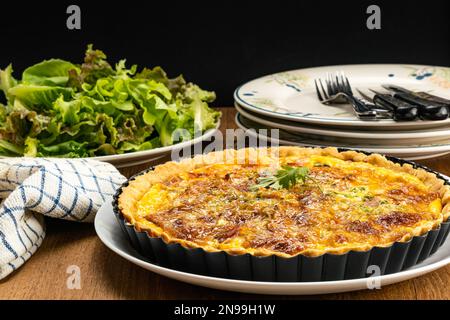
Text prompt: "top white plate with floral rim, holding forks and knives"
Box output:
[[234, 64, 450, 130]]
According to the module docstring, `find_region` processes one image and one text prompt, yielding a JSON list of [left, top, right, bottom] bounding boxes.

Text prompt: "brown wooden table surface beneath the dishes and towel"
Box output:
[[0, 108, 450, 299]]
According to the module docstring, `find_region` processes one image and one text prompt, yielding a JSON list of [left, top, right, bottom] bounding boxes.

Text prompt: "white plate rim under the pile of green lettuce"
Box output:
[[0, 121, 220, 168]]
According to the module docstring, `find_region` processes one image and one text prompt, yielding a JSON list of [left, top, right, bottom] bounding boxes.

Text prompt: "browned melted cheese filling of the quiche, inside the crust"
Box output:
[[137, 155, 442, 255]]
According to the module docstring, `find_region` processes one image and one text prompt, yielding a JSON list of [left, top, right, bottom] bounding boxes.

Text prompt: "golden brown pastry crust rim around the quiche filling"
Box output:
[[118, 147, 450, 257]]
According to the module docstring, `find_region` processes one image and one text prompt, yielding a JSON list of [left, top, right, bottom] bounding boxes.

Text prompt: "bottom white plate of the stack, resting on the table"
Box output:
[[235, 113, 450, 160]]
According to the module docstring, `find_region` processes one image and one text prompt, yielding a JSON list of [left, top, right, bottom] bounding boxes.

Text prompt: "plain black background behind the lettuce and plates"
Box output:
[[0, 0, 450, 106]]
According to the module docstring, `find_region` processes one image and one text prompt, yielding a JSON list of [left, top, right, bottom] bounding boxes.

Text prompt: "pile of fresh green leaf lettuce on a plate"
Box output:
[[0, 45, 220, 158]]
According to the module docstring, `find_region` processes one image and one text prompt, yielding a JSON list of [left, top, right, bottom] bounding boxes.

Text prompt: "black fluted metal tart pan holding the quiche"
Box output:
[[113, 149, 450, 282]]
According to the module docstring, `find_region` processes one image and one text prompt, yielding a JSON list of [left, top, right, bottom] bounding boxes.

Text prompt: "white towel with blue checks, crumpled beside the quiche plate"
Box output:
[[0, 158, 125, 279]]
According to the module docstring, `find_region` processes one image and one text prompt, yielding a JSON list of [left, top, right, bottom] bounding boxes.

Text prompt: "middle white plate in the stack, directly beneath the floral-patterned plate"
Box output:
[[235, 103, 450, 144]]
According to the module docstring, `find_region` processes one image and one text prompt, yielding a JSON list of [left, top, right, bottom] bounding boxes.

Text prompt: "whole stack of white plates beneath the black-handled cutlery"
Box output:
[[234, 65, 450, 160]]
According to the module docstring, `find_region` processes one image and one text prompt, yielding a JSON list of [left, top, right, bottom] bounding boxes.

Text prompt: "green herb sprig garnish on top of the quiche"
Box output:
[[251, 166, 309, 191]]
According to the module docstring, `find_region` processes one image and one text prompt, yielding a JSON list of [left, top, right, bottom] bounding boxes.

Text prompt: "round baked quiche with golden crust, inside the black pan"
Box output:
[[117, 147, 450, 258]]
